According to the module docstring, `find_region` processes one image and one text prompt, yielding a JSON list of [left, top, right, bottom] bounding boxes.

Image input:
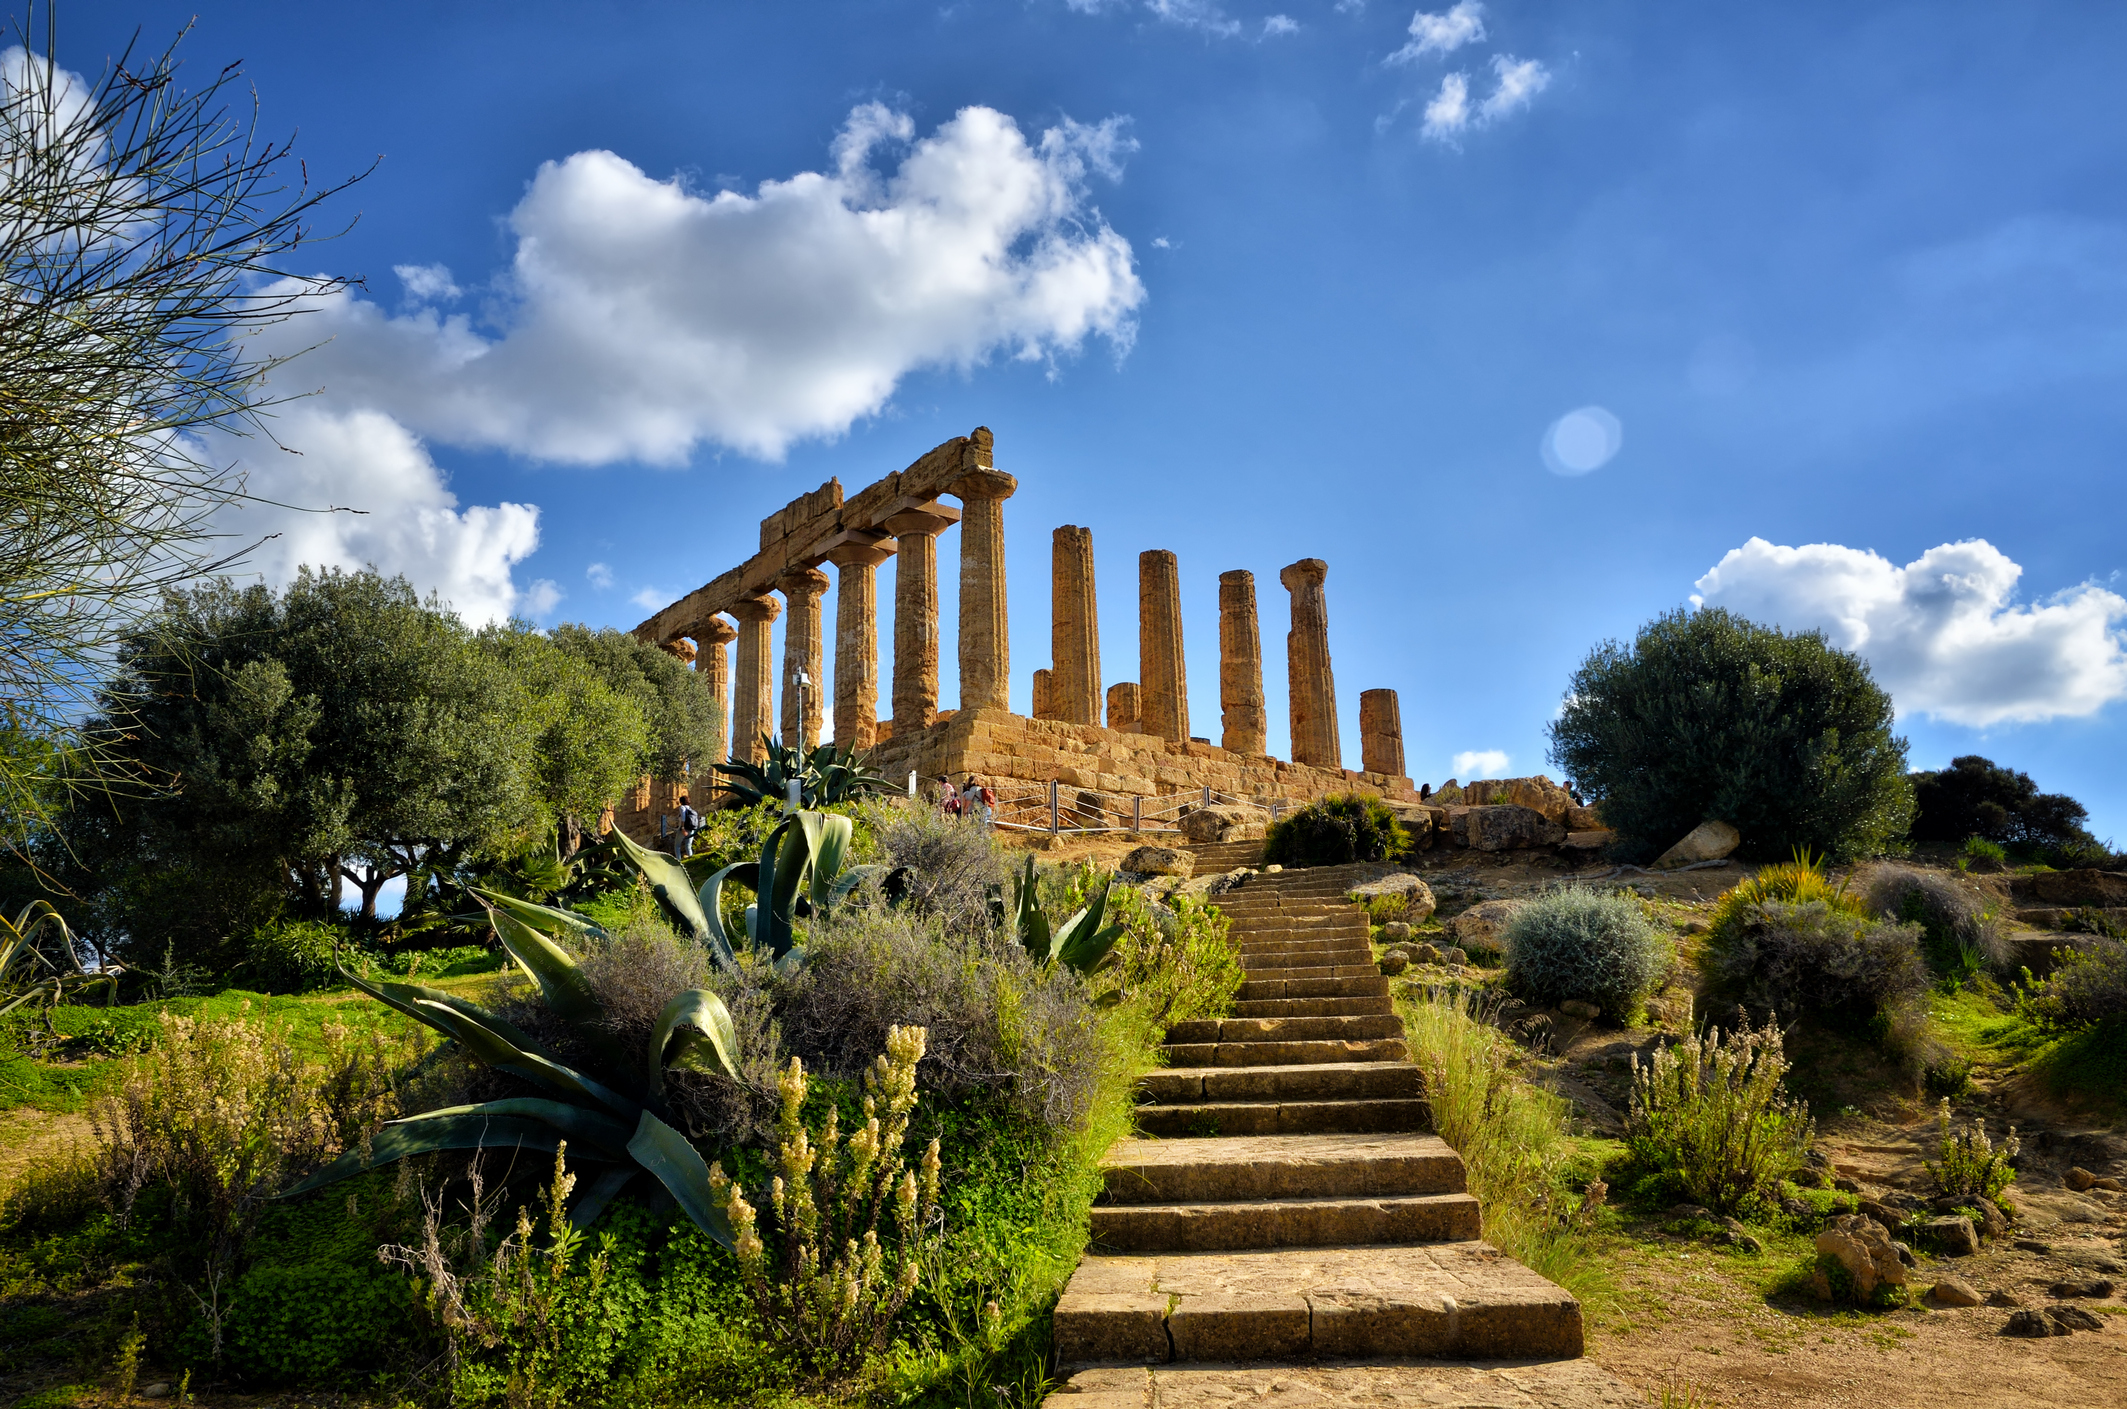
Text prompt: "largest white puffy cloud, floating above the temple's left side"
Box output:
[[257, 102, 1144, 464]]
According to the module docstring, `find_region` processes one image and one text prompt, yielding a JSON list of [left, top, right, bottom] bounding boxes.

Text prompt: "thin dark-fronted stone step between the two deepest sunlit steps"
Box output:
[[1093, 1191, 1480, 1251]]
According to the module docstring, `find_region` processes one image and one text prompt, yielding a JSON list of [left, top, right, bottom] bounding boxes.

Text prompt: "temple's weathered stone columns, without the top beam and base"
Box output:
[[663, 470, 1404, 777]]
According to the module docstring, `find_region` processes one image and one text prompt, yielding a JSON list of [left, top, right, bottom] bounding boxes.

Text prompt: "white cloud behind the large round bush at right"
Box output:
[[1691, 538, 2127, 728]]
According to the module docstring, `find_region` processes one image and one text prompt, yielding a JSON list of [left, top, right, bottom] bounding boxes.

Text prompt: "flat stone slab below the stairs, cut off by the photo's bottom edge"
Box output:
[[1042, 1360, 1646, 1409]]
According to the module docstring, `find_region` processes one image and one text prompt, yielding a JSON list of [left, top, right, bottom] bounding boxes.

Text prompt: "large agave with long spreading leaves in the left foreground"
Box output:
[[283, 892, 738, 1249]]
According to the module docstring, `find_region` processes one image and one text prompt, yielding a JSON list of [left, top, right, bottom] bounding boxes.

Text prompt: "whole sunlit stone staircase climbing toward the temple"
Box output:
[[1053, 859, 1625, 1409]]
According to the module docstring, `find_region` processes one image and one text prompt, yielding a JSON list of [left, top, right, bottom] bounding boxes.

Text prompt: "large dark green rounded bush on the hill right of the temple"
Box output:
[[1551, 609, 1912, 860]]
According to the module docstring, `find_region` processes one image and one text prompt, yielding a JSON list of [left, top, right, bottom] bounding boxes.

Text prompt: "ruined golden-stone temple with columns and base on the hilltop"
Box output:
[[615, 428, 1417, 839]]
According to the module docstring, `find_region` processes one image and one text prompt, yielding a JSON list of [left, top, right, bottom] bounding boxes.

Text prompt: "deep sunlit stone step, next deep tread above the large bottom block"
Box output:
[[1100, 1134, 1466, 1205]]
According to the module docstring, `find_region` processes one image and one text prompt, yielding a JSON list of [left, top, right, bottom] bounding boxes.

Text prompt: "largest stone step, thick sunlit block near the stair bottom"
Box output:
[[1055, 1241, 1582, 1370]]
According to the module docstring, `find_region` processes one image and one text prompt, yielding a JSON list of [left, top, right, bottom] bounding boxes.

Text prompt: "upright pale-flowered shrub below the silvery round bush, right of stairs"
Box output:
[[1625, 1024, 1816, 1215]]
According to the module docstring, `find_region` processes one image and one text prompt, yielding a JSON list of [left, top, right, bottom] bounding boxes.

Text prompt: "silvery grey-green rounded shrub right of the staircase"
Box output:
[[1504, 885, 1674, 1020]]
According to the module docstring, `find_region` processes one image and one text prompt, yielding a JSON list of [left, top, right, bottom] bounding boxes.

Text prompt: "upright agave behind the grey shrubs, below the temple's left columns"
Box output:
[[615, 811, 906, 973]]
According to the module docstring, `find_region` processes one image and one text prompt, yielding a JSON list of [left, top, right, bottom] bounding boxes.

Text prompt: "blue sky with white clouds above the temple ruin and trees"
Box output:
[[60, 0, 2127, 841]]
